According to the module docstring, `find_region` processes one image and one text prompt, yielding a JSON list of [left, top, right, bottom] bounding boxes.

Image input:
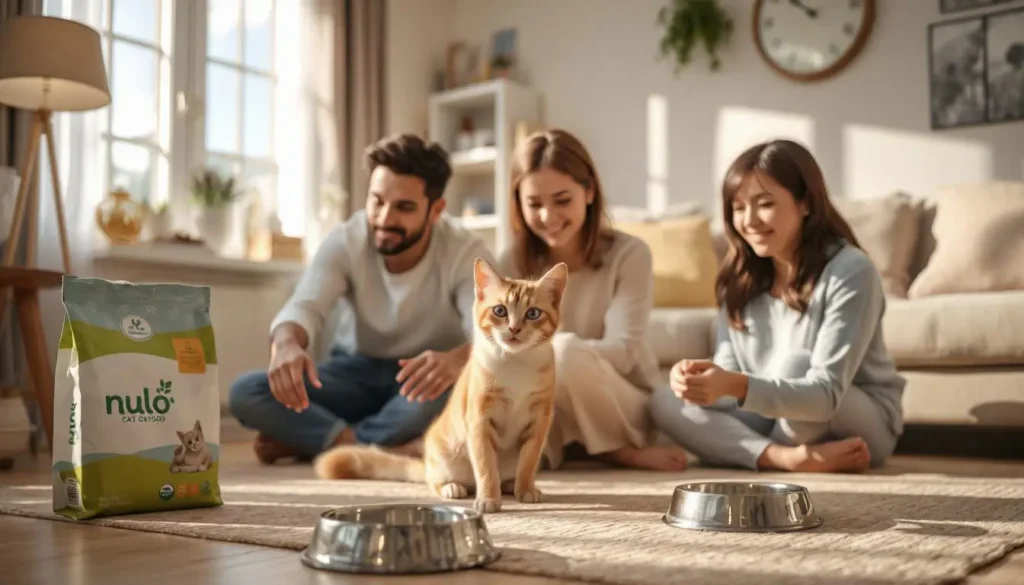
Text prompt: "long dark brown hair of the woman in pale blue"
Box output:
[[715, 140, 860, 331]]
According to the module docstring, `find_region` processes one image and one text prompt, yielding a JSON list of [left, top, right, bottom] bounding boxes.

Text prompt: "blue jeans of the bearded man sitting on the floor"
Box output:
[[229, 351, 452, 458]]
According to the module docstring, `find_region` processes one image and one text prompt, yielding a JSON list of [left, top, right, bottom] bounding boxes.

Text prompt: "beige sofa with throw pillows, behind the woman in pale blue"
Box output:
[[626, 182, 1024, 456]]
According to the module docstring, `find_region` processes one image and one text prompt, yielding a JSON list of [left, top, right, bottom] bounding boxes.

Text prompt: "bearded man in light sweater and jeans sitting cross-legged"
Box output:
[[229, 134, 495, 464]]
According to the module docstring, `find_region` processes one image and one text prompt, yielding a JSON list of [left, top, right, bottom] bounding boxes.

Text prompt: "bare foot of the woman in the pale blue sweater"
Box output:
[[758, 436, 871, 473]]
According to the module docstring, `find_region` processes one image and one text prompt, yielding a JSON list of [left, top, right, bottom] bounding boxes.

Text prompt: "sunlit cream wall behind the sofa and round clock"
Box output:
[[389, 0, 1024, 213]]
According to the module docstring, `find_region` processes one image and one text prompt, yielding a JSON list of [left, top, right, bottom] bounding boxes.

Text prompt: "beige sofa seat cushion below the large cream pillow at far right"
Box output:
[[882, 291, 1024, 367]]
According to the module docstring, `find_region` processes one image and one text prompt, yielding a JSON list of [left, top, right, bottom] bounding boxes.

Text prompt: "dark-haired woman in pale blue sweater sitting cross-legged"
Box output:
[[651, 140, 905, 472]]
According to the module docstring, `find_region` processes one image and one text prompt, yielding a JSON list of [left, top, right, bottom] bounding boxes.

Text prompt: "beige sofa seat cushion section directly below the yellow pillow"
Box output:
[[647, 307, 718, 366]]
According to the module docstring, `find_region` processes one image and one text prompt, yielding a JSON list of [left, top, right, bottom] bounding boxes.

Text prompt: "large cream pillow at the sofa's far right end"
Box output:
[[908, 181, 1024, 298]]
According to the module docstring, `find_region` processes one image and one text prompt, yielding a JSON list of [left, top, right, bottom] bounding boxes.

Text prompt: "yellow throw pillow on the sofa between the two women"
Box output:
[[615, 215, 718, 307]]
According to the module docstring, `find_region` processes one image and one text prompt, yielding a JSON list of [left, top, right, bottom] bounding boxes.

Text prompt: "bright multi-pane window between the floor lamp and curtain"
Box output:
[[44, 0, 305, 235]]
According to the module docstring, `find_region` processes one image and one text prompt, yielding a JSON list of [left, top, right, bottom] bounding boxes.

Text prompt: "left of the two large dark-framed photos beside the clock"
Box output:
[[928, 16, 988, 129]]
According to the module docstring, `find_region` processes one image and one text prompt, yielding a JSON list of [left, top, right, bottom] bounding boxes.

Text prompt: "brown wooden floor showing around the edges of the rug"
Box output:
[[0, 446, 1024, 585]]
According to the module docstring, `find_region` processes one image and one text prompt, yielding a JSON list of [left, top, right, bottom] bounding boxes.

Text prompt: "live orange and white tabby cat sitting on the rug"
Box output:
[[313, 258, 568, 512]]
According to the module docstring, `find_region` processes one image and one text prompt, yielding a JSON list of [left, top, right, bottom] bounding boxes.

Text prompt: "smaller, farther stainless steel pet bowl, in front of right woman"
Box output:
[[662, 482, 821, 532]]
